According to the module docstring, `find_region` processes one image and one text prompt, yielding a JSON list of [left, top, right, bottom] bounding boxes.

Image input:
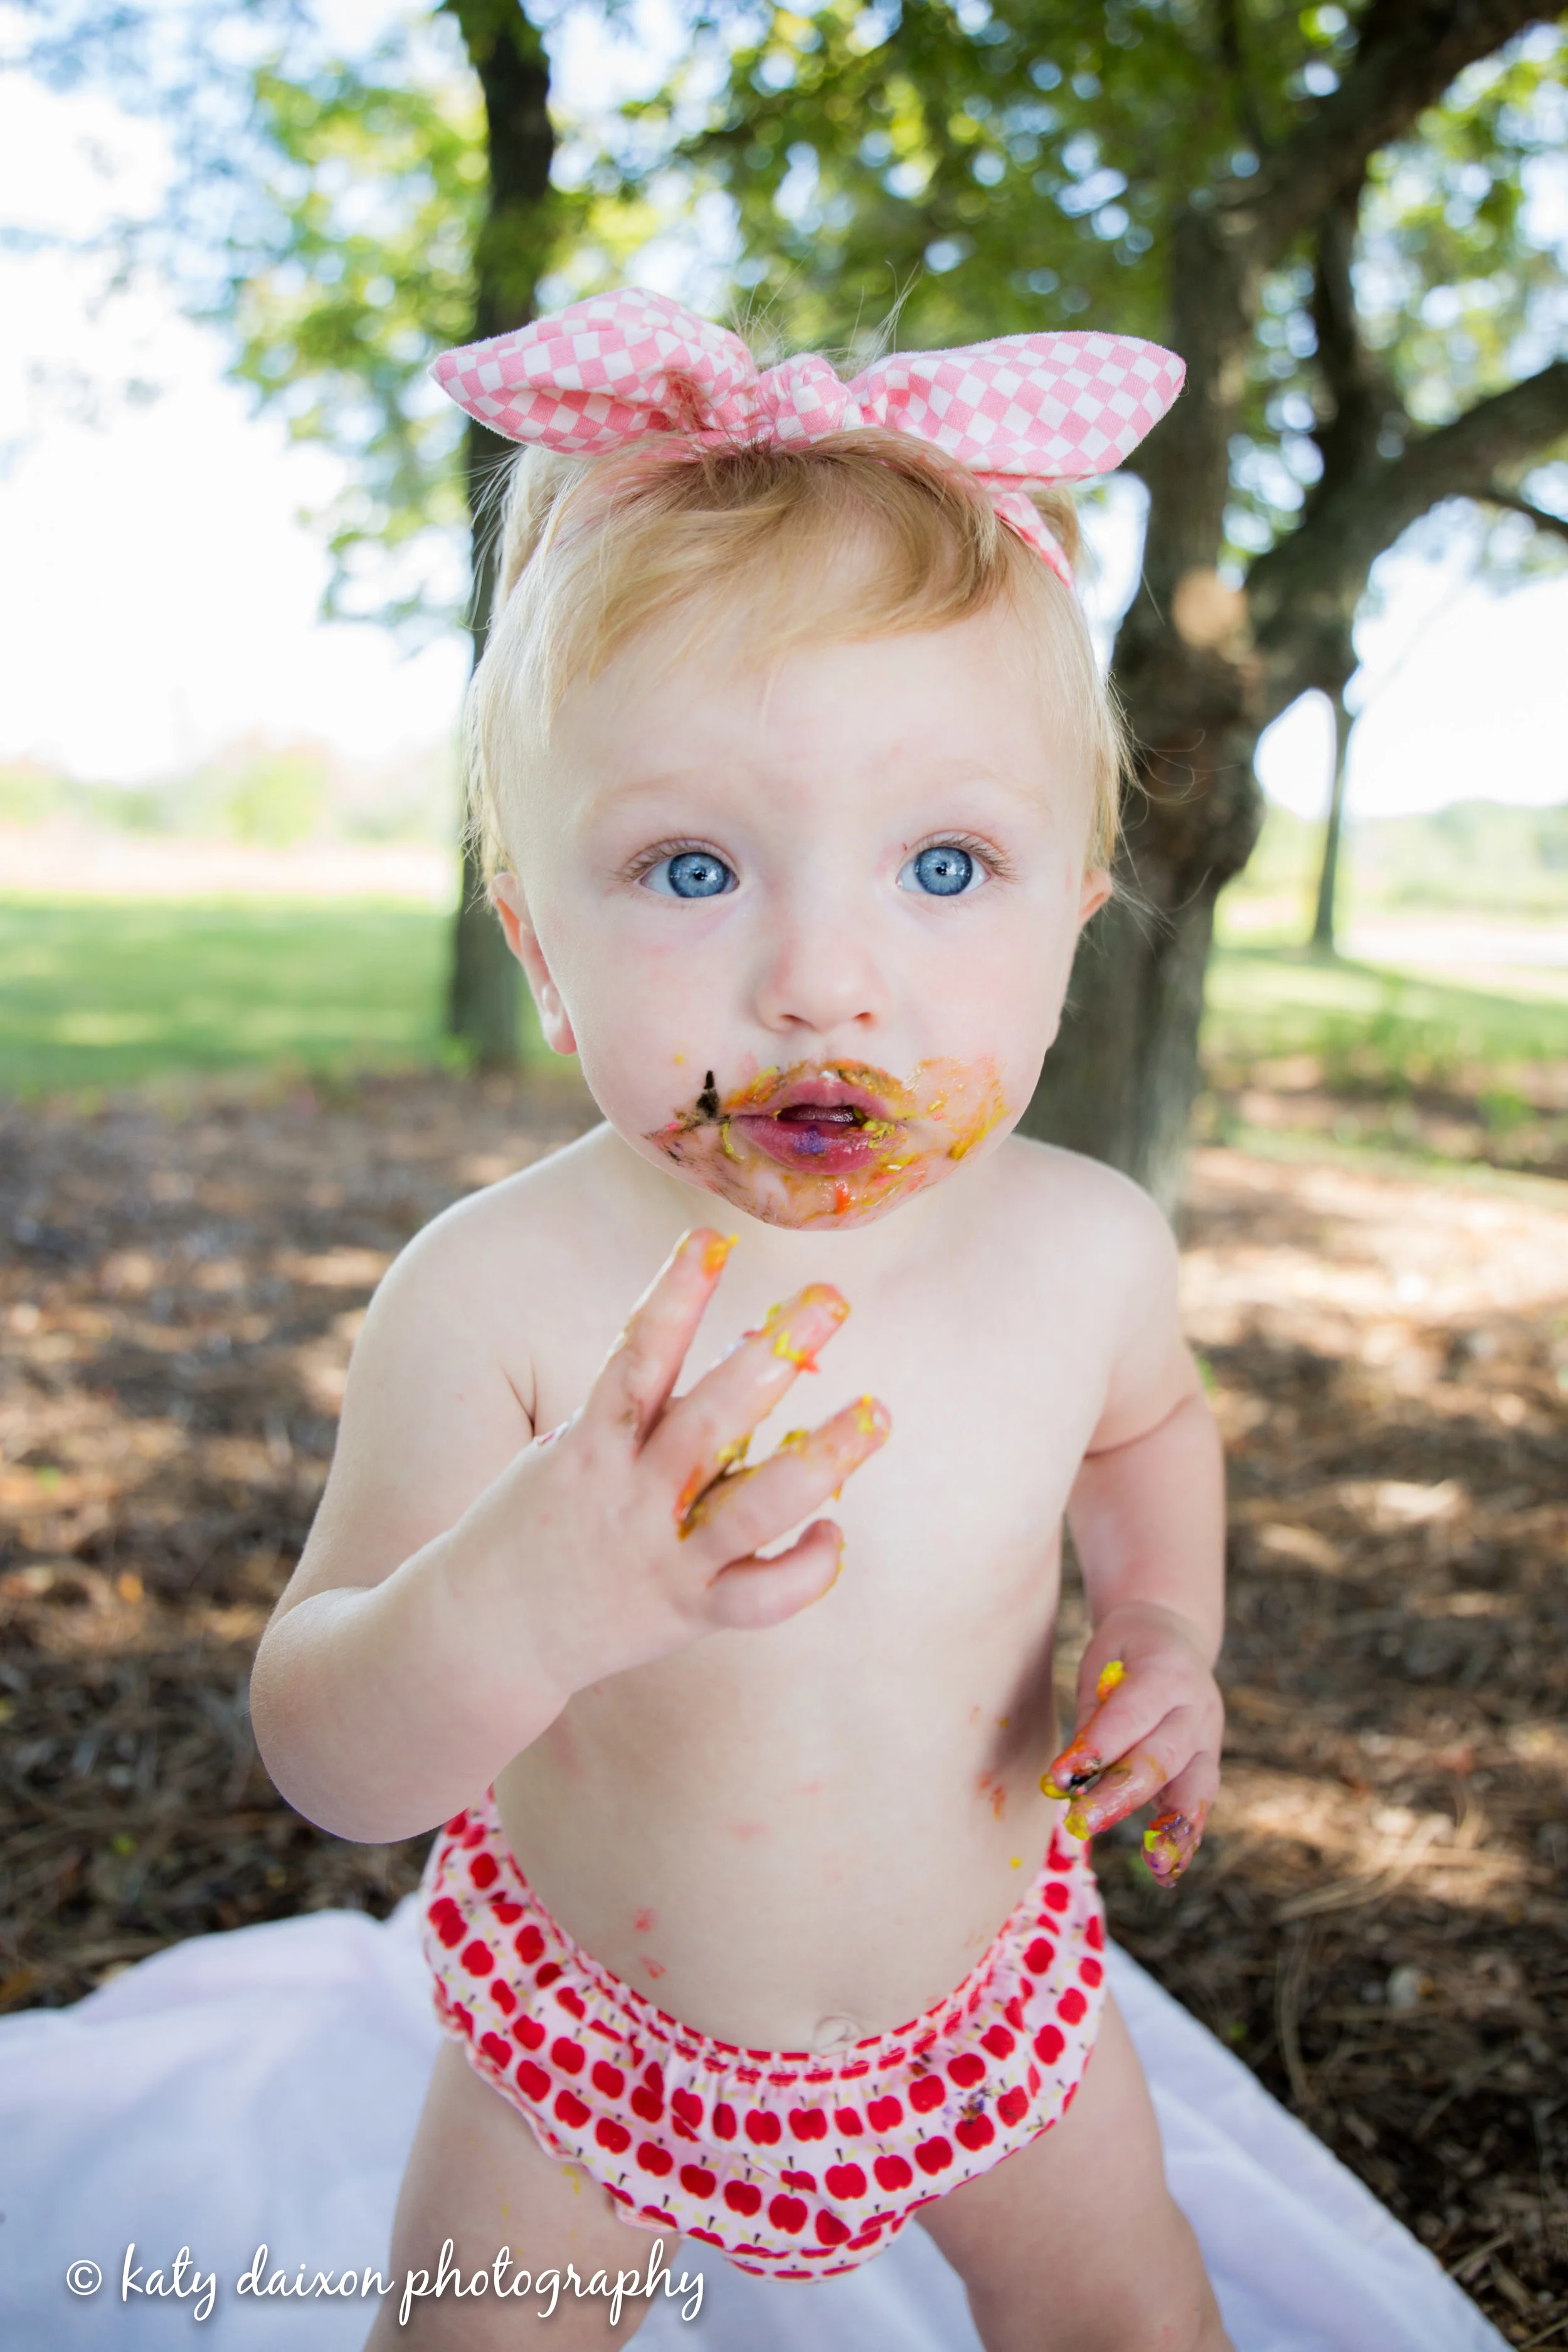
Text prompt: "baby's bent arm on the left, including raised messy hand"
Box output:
[[252, 1232, 889, 1841]]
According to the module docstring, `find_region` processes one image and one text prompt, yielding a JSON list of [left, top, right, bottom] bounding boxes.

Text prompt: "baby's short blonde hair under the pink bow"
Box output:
[[465, 428, 1128, 875]]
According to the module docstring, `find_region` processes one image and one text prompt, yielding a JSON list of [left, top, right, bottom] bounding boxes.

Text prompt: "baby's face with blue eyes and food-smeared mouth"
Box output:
[[496, 612, 1107, 1228]]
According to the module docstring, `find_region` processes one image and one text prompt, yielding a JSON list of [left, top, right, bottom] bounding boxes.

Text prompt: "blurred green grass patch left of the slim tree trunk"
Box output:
[[0, 899, 463, 1096]]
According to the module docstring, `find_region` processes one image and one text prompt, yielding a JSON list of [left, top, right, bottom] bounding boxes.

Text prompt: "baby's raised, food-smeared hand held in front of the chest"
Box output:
[[515, 1230, 889, 1689]]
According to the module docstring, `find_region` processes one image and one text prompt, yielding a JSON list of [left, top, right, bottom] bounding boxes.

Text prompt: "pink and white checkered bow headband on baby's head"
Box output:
[[430, 287, 1187, 586]]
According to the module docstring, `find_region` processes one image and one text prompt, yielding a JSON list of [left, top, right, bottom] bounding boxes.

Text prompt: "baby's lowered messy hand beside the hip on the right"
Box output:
[[1039, 1602, 1225, 1887]]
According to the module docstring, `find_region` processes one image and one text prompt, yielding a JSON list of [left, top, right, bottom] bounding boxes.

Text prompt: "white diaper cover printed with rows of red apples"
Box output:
[[421, 1793, 1105, 2279]]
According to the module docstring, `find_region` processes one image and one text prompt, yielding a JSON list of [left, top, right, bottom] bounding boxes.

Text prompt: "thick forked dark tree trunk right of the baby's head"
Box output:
[[1022, 36, 1568, 1209]]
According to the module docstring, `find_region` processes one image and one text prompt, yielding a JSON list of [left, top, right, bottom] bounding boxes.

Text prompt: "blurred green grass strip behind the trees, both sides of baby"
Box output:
[[0, 899, 1568, 1096]]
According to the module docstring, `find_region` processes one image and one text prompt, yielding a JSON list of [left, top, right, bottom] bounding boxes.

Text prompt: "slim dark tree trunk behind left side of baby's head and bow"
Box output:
[[447, 0, 555, 1070]]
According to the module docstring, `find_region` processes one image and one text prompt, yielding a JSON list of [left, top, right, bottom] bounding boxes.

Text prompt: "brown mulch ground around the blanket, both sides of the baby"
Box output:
[[0, 1078, 1568, 2348]]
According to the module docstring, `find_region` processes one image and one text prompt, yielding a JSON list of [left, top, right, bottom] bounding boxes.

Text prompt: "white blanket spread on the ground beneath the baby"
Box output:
[[0, 1898, 1502, 2352]]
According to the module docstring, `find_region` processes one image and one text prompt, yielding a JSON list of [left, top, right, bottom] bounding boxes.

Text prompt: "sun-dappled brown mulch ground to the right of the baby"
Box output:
[[1062, 1150, 1568, 2343]]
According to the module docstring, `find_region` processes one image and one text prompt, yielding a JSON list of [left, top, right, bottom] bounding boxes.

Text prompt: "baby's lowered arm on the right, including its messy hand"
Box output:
[[1041, 1202, 1225, 1882]]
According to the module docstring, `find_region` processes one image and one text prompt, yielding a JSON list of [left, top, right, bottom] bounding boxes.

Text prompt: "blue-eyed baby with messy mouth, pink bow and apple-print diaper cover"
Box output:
[[254, 294, 1225, 2352]]
